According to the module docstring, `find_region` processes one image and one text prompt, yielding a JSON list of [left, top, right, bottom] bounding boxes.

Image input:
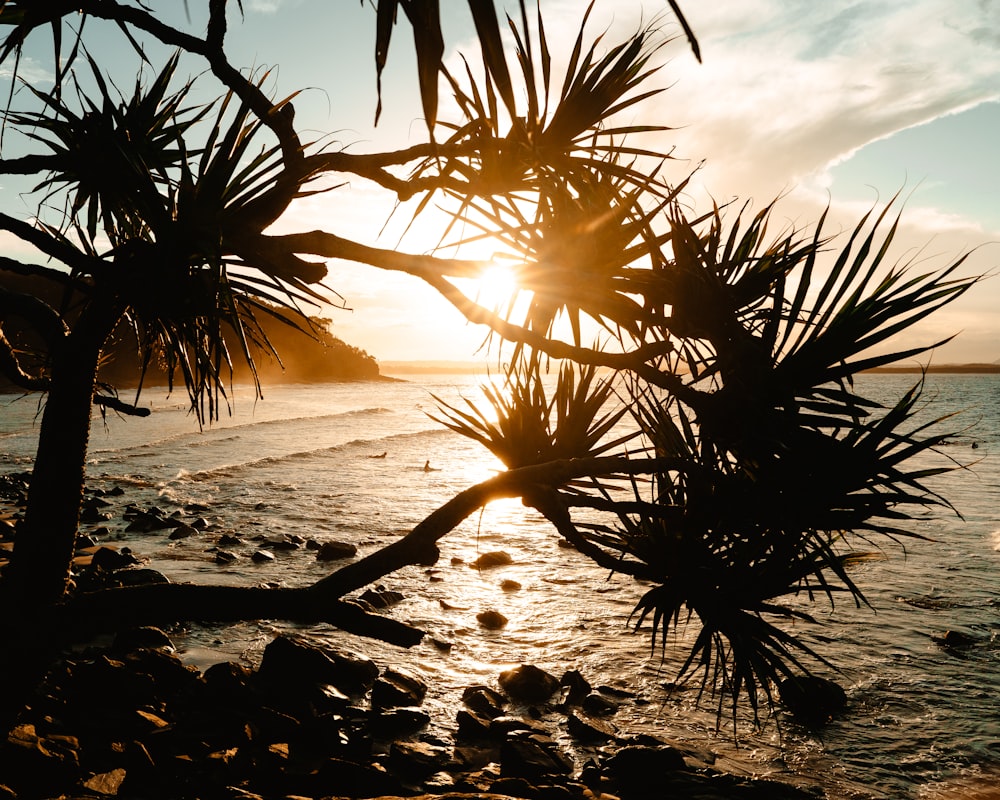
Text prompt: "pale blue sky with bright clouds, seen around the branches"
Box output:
[[0, 0, 1000, 363]]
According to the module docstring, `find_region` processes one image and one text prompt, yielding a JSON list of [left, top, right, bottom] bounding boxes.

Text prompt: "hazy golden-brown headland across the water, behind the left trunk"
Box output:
[[0, 270, 392, 392]]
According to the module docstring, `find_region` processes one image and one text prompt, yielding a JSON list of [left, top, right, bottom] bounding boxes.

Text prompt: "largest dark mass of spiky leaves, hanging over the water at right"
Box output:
[[560, 198, 976, 718]]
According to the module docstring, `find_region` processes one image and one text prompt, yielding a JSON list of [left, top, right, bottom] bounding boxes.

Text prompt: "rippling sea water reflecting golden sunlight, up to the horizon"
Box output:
[[0, 374, 1000, 800]]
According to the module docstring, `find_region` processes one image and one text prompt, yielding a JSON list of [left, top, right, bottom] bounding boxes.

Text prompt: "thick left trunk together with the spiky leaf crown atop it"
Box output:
[[1, 55, 325, 602]]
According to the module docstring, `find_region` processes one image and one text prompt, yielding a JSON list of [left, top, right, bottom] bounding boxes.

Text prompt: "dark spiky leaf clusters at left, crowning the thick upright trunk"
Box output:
[[17, 50, 326, 419]]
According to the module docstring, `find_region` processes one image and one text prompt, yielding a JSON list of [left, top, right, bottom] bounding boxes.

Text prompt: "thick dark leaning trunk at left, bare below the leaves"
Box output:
[[5, 302, 120, 613]]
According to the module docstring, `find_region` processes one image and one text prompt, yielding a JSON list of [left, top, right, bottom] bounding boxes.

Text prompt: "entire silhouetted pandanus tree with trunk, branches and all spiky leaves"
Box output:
[[0, 0, 976, 732]]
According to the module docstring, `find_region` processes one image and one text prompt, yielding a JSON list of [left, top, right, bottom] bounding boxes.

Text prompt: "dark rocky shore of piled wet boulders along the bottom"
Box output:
[[0, 480, 824, 800]]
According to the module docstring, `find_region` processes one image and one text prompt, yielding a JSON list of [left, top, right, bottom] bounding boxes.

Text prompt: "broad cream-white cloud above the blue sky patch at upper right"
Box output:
[[624, 0, 1000, 203]]
